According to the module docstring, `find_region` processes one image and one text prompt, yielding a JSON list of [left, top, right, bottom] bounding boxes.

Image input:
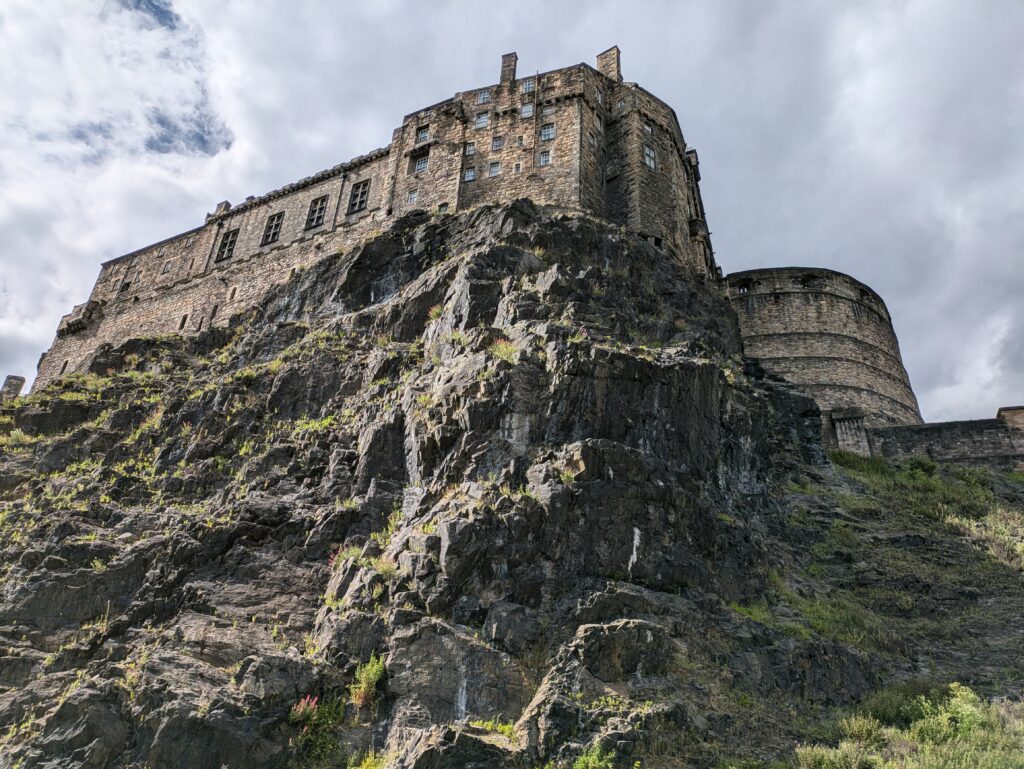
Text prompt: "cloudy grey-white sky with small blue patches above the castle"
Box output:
[[0, 0, 1024, 420]]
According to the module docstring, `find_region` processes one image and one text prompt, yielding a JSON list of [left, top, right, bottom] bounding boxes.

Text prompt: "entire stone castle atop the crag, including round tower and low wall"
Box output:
[[6, 47, 1024, 468]]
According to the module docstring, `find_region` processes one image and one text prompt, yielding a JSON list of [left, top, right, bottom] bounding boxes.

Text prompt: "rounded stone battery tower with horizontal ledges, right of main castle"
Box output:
[[725, 267, 922, 434]]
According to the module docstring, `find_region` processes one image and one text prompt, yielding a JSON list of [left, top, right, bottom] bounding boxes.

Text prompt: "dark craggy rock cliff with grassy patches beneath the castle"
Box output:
[[0, 202, 1024, 769]]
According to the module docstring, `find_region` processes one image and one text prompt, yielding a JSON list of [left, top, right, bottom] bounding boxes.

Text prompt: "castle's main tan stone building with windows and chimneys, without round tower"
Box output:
[[37, 48, 718, 384]]
